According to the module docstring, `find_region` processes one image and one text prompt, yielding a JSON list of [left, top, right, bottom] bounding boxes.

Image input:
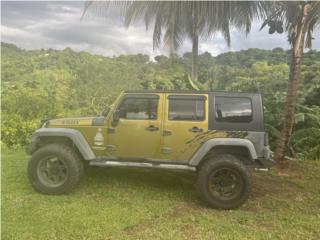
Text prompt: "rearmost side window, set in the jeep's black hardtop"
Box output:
[[215, 97, 252, 123]]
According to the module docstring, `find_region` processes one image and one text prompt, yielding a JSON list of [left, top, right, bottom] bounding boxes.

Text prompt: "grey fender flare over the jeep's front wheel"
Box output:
[[27, 128, 96, 160]]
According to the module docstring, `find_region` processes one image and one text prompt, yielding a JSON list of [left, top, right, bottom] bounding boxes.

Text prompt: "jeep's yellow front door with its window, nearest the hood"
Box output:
[[107, 94, 162, 159]]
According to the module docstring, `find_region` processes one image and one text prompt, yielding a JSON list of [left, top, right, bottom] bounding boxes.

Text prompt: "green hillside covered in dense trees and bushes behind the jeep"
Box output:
[[1, 43, 320, 158]]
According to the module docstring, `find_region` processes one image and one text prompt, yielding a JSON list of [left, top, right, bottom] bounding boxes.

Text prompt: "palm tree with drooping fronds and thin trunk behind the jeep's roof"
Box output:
[[84, 1, 261, 82]]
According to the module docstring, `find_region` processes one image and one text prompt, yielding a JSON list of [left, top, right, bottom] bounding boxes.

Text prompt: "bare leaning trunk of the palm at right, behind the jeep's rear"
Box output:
[[274, 4, 309, 165]]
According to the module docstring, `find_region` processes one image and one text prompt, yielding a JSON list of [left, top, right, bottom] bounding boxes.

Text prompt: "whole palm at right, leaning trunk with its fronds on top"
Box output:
[[261, 1, 320, 163]]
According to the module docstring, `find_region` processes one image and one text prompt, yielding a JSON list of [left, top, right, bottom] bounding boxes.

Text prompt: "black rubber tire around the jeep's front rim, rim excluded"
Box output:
[[28, 144, 84, 195]]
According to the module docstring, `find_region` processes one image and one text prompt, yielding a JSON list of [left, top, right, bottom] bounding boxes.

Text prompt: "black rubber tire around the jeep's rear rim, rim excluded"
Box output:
[[197, 154, 252, 209]]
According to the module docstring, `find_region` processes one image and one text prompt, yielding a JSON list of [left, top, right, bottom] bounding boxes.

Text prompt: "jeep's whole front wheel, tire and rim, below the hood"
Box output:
[[28, 144, 83, 194]]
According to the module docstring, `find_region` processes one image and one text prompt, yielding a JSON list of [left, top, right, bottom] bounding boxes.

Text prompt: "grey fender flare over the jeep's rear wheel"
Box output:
[[189, 138, 258, 166]]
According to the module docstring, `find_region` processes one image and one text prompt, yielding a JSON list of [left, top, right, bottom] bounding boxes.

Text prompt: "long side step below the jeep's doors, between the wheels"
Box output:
[[89, 160, 196, 172]]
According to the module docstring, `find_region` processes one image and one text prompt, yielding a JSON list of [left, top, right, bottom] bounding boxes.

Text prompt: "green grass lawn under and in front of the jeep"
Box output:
[[1, 151, 320, 240]]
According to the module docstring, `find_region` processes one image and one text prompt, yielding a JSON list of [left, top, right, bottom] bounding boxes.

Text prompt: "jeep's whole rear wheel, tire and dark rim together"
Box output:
[[197, 154, 251, 209]]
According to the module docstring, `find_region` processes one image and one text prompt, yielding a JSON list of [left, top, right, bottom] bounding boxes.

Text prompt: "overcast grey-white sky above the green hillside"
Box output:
[[1, 1, 320, 57]]
